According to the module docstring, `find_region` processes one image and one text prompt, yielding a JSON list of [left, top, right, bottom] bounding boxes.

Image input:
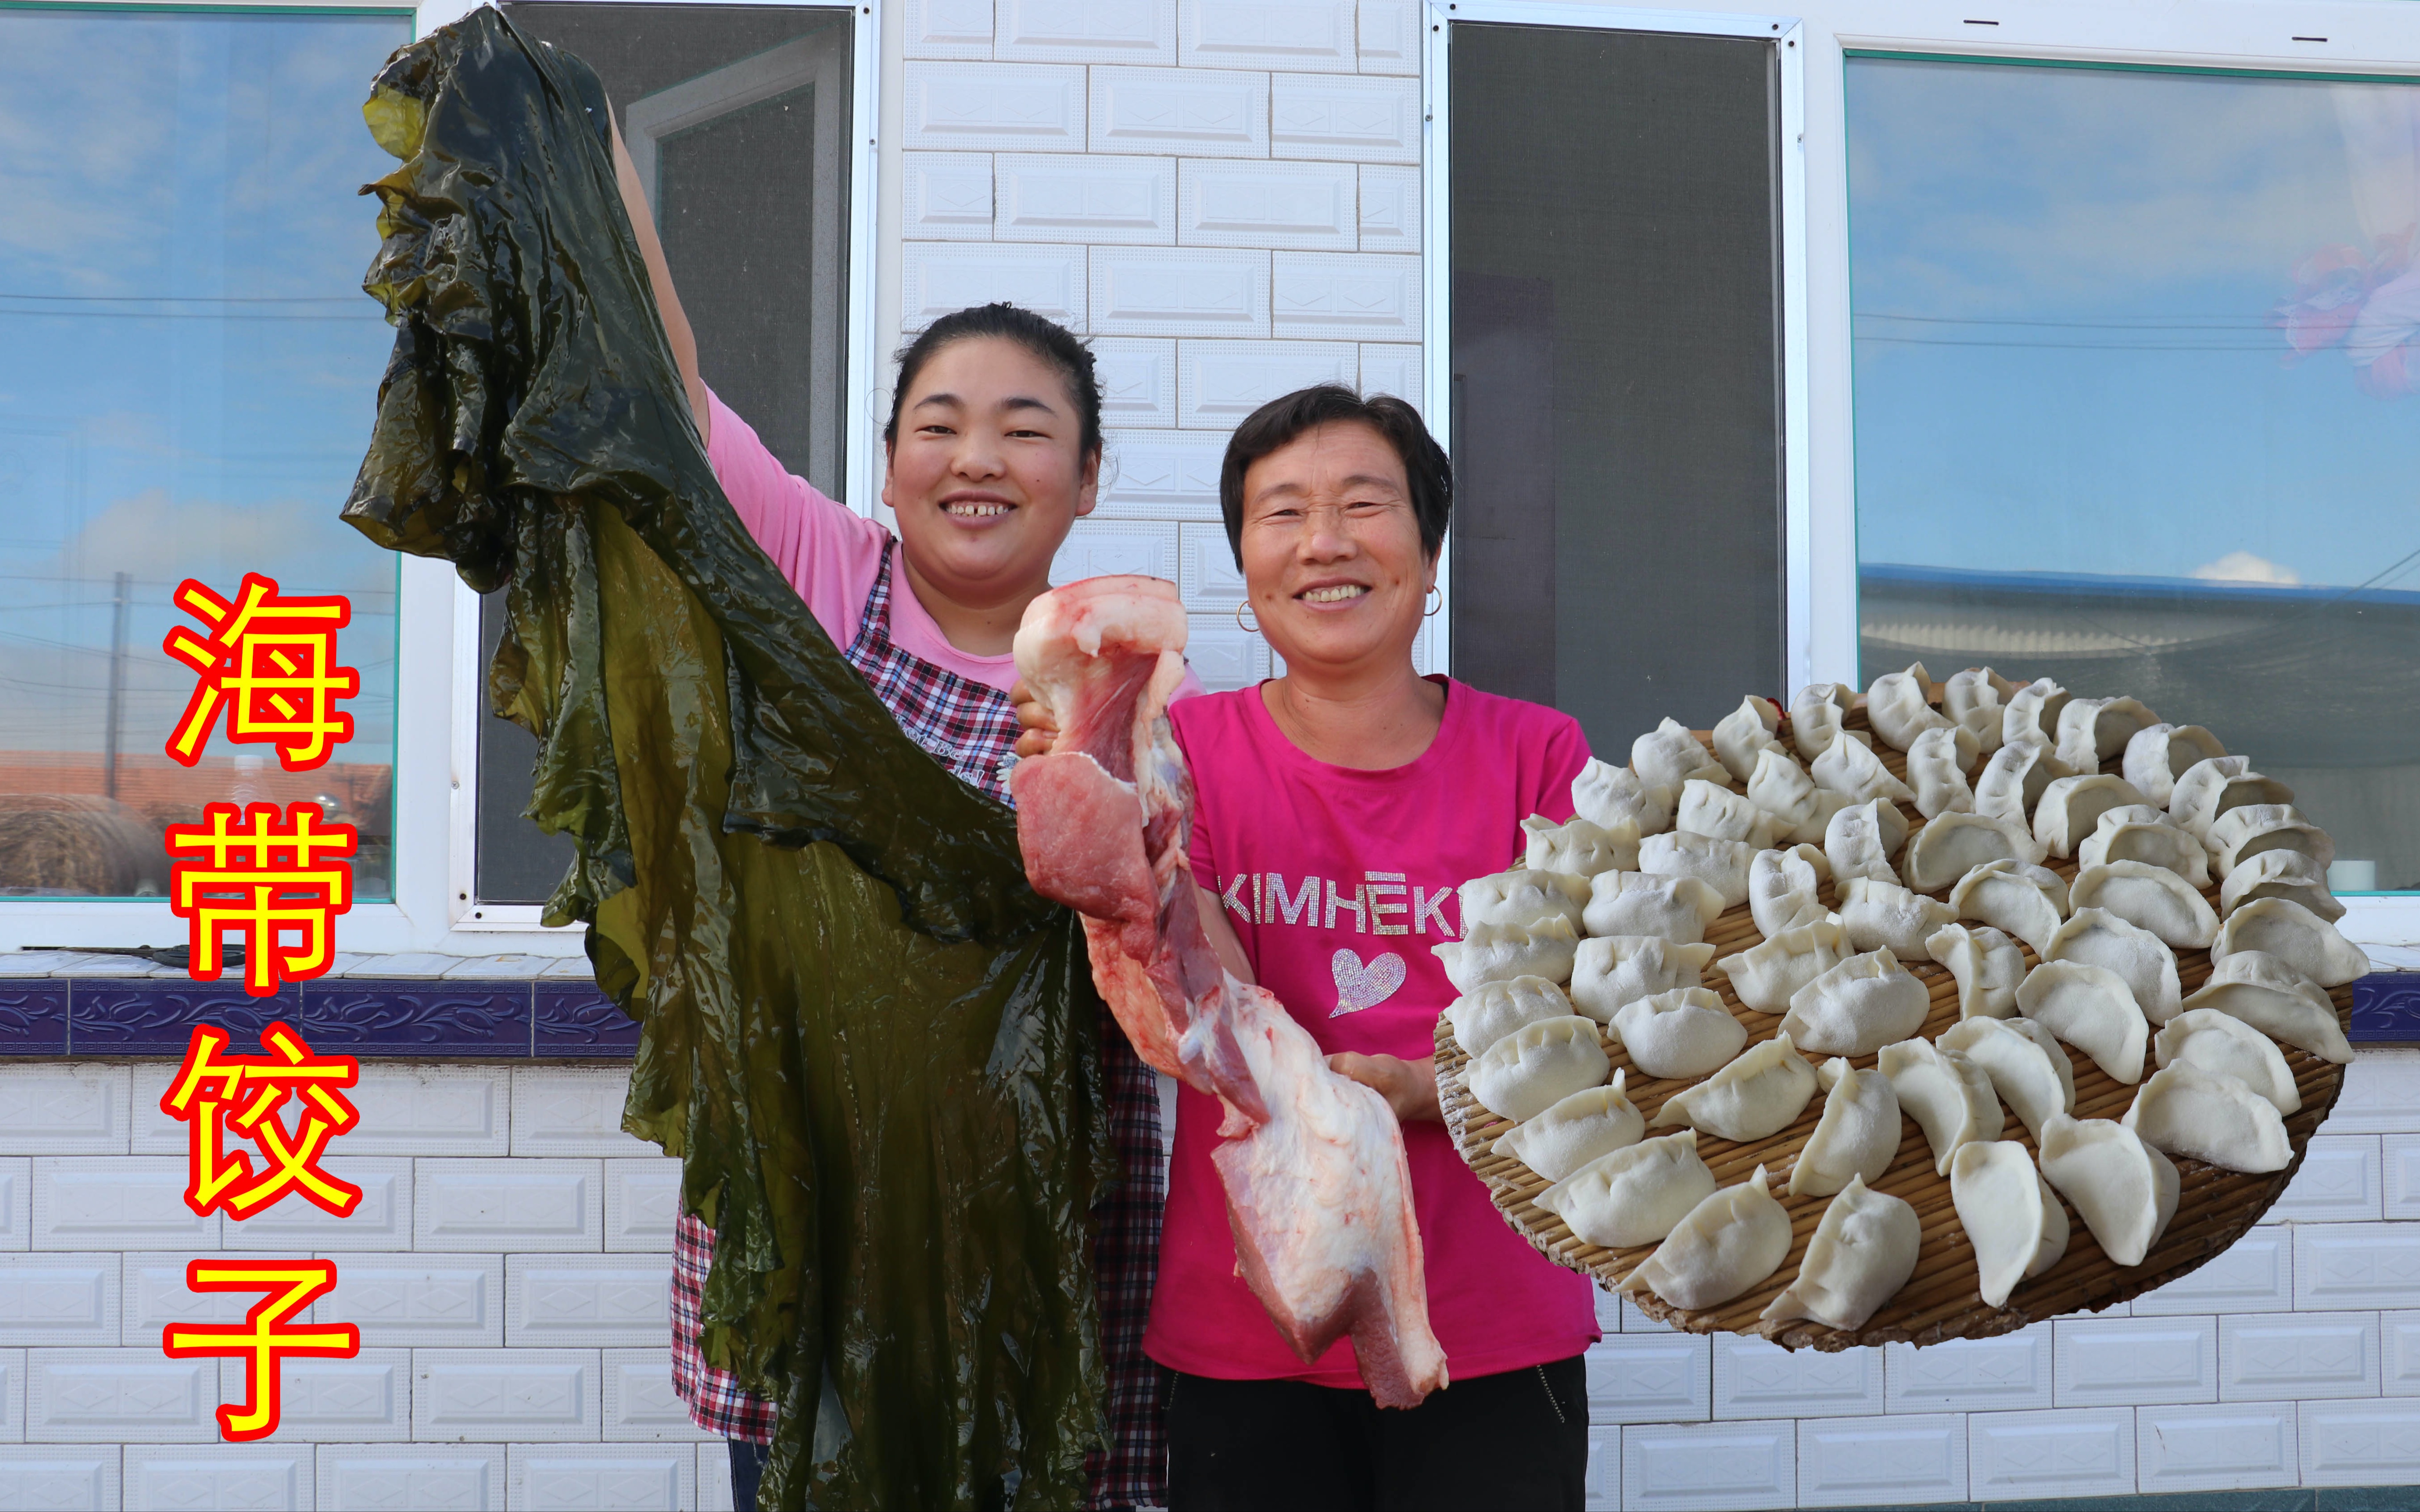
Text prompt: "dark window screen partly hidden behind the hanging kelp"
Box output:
[[477, 0, 852, 902]]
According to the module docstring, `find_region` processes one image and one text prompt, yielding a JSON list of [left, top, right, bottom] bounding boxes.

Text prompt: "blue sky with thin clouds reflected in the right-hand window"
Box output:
[[1849, 58, 2420, 588]]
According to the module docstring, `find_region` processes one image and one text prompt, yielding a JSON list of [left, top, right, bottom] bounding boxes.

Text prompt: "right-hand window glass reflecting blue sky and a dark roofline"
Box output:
[[1846, 58, 2420, 890]]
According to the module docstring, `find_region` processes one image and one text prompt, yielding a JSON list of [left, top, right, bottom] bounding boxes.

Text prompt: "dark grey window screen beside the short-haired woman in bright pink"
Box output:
[[1450, 24, 1784, 760]]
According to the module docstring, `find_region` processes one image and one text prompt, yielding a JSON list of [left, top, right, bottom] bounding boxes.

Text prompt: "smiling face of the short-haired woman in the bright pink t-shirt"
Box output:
[[1241, 421, 1435, 675]]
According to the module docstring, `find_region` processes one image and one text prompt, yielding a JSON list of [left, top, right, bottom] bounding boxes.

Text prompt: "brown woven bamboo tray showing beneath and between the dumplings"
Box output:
[[1435, 697, 2352, 1350]]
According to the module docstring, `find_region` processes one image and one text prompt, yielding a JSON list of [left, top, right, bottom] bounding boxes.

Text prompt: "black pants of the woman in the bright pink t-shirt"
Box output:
[[1169, 1355, 1587, 1512]]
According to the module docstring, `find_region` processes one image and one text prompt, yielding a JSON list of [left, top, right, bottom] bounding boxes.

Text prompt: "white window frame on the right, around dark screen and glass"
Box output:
[[1421, 0, 2420, 946]]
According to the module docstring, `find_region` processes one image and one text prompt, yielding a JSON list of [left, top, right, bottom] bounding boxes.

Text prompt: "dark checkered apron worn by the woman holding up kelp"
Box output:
[[673, 539, 1169, 1507]]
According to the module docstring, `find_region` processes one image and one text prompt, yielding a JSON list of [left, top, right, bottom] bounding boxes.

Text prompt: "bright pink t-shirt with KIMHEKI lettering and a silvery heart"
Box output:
[[1142, 680, 1597, 1386]]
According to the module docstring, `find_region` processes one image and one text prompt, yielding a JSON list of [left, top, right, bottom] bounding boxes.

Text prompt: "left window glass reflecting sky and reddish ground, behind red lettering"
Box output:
[[0, 10, 411, 897]]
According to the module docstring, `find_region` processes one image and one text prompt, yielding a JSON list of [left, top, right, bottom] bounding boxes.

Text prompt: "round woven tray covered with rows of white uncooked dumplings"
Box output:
[[1435, 665, 2367, 1350]]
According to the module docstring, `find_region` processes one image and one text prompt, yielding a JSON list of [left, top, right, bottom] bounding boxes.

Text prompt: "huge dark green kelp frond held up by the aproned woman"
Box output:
[[346, 10, 1113, 1510]]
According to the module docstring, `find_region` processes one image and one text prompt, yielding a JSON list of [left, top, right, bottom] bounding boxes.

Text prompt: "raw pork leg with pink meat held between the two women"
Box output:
[[1009, 578, 1445, 1408]]
